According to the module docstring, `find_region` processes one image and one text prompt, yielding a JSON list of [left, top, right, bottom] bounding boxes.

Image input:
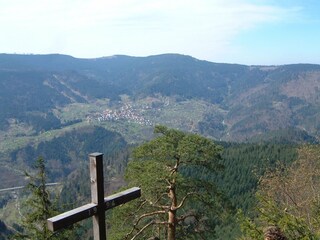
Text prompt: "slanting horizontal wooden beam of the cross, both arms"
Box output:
[[47, 187, 141, 232]]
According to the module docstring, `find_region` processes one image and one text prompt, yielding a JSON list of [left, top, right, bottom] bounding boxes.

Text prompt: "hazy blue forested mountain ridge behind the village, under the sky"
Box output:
[[0, 54, 320, 141]]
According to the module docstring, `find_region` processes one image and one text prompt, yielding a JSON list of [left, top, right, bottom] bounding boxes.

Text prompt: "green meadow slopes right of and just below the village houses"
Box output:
[[95, 98, 218, 143]]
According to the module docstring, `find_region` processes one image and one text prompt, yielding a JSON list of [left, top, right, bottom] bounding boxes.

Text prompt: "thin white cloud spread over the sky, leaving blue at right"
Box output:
[[0, 0, 300, 60]]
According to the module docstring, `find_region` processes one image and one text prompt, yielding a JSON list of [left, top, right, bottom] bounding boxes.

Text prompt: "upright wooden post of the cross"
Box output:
[[89, 153, 106, 240]]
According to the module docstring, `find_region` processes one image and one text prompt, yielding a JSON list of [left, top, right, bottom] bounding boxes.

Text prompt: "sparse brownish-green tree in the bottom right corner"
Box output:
[[242, 145, 320, 239]]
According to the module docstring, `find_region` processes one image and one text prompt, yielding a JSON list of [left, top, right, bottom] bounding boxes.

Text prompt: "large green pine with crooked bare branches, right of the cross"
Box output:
[[110, 126, 229, 240]]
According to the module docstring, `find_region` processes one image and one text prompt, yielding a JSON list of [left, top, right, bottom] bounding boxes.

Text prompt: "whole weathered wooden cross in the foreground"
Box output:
[[47, 153, 141, 240]]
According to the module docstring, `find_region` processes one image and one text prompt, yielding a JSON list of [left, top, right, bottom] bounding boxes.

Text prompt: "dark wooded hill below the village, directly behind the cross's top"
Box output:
[[3, 127, 127, 182]]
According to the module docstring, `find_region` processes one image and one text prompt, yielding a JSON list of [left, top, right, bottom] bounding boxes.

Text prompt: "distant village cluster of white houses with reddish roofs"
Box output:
[[89, 103, 153, 126]]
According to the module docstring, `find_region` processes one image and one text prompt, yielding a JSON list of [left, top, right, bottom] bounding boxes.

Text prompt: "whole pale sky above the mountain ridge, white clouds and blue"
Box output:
[[0, 0, 320, 65]]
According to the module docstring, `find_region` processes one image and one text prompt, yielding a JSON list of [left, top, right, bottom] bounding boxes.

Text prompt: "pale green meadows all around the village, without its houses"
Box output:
[[0, 97, 220, 152]]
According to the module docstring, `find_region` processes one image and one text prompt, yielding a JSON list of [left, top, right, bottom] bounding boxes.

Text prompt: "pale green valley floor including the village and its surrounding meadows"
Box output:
[[0, 96, 223, 152]]
